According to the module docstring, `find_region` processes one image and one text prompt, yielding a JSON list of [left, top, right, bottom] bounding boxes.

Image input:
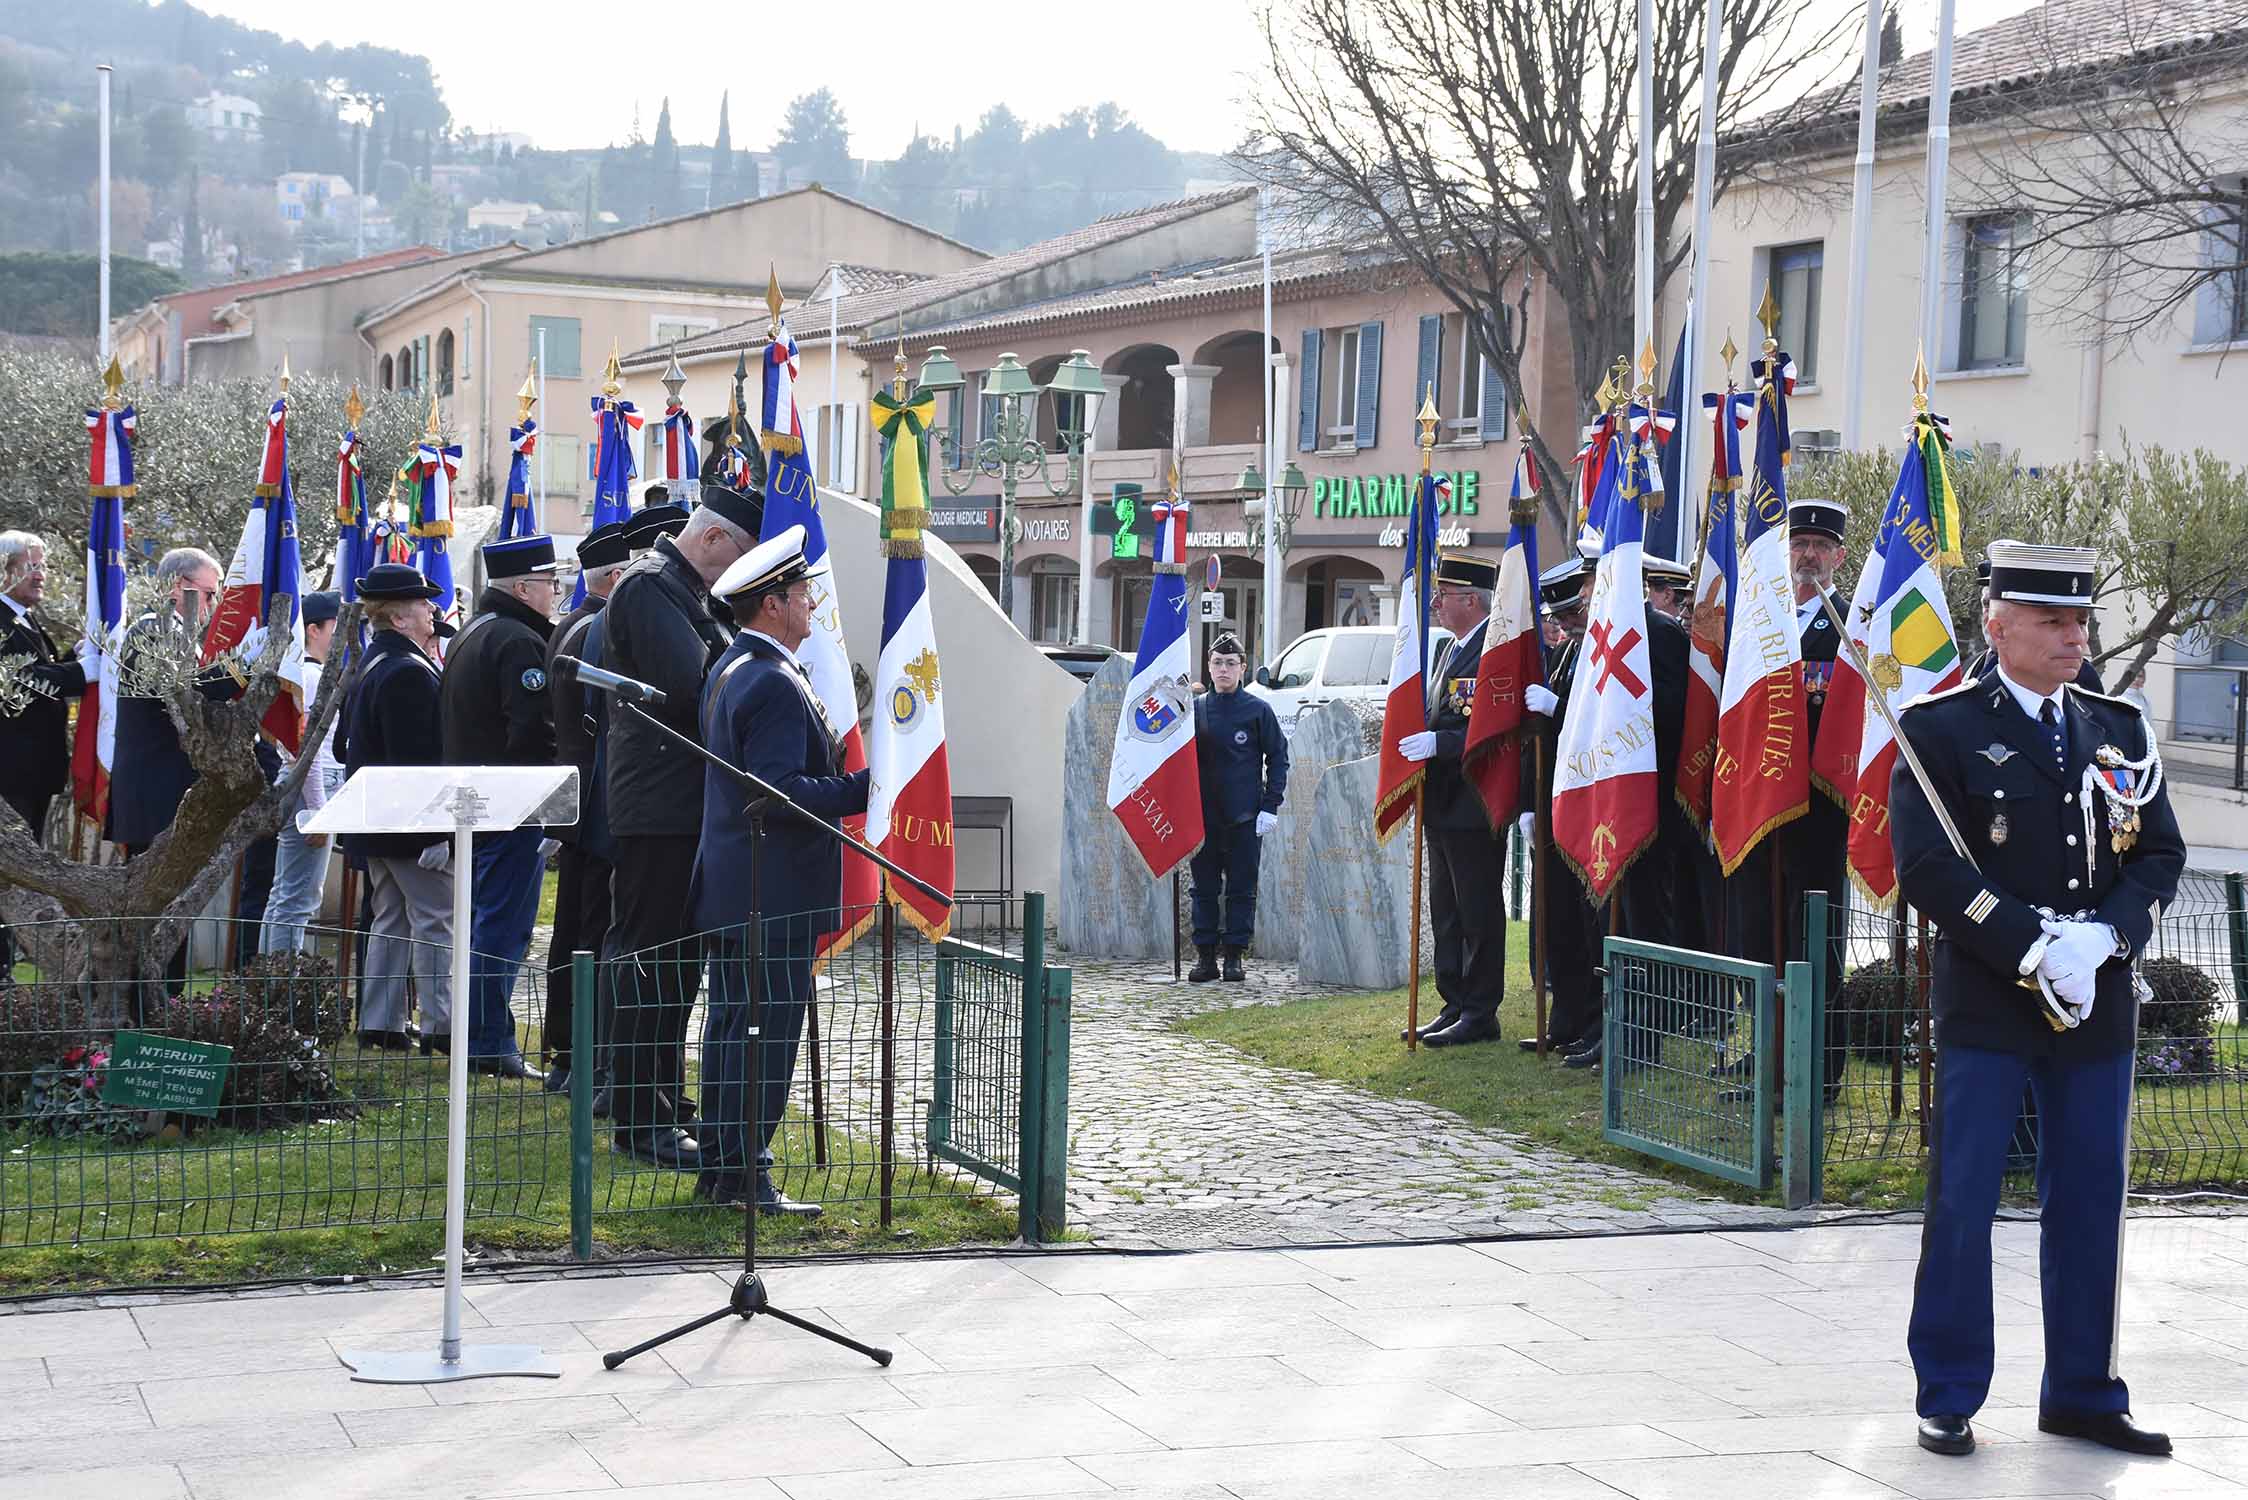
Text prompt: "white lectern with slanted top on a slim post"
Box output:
[[297, 765, 578, 1385]]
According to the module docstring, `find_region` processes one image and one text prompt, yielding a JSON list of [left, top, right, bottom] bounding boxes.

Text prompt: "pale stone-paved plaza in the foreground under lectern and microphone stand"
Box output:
[[0, 1219, 2248, 1500]]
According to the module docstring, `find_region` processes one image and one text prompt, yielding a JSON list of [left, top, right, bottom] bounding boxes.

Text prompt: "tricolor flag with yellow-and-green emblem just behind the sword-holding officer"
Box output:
[[1814, 412, 1965, 909]]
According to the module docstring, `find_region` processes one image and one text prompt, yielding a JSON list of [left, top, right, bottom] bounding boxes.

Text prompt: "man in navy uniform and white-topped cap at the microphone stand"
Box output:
[[688, 526, 868, 1217]]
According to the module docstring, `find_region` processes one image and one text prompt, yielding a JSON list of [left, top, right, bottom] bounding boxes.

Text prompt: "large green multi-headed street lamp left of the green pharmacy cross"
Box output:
[[922, 346, 1108, 621]]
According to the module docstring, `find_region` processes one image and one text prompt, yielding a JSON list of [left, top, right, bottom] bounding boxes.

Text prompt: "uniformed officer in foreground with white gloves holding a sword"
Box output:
[[1888, 542, 2185, 1453]]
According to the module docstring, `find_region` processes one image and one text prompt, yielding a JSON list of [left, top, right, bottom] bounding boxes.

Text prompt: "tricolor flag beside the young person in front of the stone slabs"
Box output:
[[1108, 488, 1203, 879]]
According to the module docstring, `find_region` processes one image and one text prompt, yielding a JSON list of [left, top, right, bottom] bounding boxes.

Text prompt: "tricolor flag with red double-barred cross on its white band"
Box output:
[[1553, 436, 1657, 904]]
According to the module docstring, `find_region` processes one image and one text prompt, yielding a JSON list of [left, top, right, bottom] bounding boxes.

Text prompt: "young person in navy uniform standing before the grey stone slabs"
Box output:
[[1187, 630, 1288, 985]]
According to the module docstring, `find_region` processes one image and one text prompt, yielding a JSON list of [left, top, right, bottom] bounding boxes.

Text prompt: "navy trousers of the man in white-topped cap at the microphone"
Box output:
[[695, 920, 818, 1183]]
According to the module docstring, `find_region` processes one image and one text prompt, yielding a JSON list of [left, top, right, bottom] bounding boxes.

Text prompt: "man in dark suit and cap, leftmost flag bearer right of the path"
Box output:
[[1398, 553, 1506, 1048]]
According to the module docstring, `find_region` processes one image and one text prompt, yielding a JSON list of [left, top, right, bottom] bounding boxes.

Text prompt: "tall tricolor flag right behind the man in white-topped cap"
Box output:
[[760, 324, 881, 954]]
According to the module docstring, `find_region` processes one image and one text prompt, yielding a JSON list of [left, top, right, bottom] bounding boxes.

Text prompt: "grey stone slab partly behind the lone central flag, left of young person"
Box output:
[[1057, 657, 1171, 958]]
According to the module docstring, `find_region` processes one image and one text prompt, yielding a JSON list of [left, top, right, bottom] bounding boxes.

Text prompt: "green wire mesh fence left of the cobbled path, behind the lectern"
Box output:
[[0, 897, 1068, 1253]]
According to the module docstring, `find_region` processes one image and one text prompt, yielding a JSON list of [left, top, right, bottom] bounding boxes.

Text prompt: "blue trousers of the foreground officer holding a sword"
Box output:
[[1906, 1046, 2133, 1417]]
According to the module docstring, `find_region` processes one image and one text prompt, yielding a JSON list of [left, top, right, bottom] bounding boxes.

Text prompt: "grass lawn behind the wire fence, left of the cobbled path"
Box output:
[[0, 1041, 1014, 1291]]
